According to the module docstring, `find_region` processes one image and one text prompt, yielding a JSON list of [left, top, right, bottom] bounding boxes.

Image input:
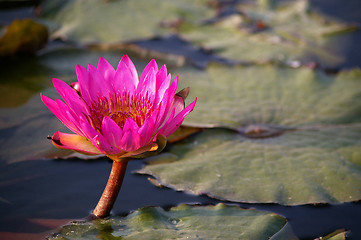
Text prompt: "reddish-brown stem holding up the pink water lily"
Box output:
[[93, 159, 128, 218]]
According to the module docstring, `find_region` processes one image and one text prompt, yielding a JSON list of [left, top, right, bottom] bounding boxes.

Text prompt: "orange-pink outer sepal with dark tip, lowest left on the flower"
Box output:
[[51, 131, 101, 155]]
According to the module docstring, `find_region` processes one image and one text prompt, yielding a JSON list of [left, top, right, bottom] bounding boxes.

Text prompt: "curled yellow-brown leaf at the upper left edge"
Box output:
[[0, 19, 48, 57]]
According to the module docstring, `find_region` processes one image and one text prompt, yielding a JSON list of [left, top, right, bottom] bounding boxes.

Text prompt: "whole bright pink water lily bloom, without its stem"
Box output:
[[41, 55, 196, 161]]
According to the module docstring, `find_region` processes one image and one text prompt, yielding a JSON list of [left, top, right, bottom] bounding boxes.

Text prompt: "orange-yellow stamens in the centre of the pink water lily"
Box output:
[[90, 92, 154, 132]]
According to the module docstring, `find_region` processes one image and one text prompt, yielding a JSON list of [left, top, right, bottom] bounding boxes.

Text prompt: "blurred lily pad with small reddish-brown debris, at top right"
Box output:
[[180, 0, 355, 66]]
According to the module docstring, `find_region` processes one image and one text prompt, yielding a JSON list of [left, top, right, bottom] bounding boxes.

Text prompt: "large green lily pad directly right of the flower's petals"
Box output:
[[176, 65, 361, 129]]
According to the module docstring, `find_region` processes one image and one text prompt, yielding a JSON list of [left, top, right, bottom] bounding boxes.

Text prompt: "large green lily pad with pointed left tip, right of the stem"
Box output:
[[139, 124, 361, 205]]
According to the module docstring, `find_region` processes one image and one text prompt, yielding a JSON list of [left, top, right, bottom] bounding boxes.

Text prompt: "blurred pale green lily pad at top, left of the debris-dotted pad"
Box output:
[[42, 0, 213, 43]]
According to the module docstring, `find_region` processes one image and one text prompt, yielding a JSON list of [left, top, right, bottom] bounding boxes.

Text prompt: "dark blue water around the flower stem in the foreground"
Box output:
[[0, 158, 361, 240]]
